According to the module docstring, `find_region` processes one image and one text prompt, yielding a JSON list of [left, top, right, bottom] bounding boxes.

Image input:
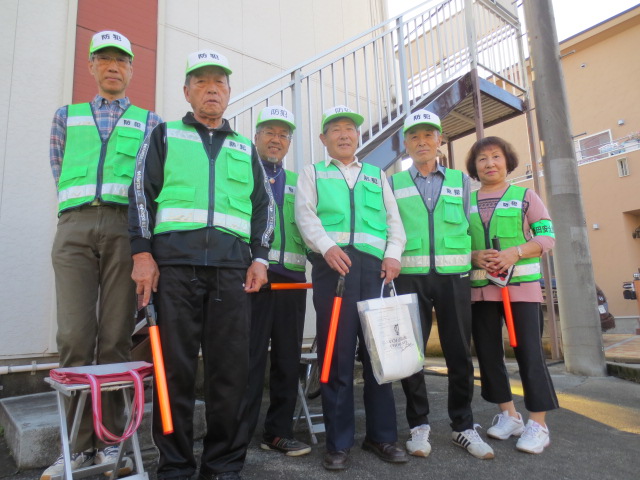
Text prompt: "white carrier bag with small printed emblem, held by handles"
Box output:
[[358, 282, 424, 385]]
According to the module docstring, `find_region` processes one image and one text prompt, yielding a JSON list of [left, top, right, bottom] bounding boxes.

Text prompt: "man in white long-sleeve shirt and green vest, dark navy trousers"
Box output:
[[296, 106, 407, 470]]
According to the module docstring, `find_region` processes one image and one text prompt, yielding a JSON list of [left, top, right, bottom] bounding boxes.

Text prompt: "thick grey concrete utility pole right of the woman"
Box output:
[[524, 0, 606, 376]]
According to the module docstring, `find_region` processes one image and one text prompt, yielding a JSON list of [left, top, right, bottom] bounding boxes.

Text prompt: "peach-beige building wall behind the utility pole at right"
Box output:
[[454, 7, 640, 324]]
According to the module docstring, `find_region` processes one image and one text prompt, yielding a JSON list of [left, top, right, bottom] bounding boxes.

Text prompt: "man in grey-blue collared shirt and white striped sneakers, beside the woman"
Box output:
[[391, 110, 493, 459]]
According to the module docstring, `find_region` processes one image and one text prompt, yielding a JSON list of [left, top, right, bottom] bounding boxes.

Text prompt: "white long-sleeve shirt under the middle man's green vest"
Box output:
[[295, 157, 407, 261]]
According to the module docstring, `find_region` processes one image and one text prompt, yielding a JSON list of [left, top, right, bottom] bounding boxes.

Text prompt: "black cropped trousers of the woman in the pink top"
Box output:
[[471, 302, 558, 412]]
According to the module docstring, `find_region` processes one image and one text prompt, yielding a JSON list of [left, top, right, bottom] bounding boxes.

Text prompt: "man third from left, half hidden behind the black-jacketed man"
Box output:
[[242, 106, 311, 457]]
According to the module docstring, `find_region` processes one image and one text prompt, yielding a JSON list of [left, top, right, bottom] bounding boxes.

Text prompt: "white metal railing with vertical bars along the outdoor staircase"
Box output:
[[228, 0, 526, 171]]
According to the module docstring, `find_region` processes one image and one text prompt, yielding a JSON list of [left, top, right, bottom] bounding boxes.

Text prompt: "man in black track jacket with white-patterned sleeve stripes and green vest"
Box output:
[[129, 50, 274, 480]]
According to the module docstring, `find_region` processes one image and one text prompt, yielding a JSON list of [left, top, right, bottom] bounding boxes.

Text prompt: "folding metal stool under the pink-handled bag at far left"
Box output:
[[44, 362, 153, 480]]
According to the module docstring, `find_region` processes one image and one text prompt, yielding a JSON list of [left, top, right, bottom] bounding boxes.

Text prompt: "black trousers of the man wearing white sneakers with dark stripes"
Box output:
[[395, 273, 473, 432]]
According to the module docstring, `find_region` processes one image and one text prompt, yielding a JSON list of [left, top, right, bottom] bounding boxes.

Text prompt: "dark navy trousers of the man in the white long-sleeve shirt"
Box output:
[[312, 249, 398, 451]]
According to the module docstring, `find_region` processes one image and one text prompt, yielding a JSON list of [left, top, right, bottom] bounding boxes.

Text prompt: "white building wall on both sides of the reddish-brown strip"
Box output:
[[0, 0, 386, 364]]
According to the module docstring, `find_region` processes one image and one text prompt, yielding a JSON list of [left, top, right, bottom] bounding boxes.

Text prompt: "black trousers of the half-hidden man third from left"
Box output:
[[245, 272, 307, 441]]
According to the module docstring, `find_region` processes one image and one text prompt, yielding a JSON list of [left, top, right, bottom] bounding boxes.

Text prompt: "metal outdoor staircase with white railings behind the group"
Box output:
[[228, 0, 527, 171]]
